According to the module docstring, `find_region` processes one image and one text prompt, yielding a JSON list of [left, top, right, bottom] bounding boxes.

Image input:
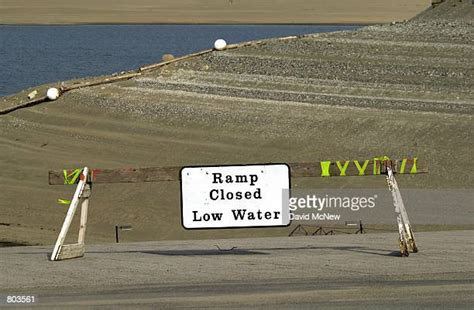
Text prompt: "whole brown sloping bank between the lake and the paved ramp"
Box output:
[[0, 1, 474, 244]]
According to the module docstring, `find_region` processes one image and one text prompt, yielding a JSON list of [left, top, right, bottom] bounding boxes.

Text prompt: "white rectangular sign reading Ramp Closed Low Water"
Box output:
[[180, 164, 290, 229]]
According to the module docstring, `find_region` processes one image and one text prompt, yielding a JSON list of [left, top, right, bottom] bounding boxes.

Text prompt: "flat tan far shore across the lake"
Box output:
[[0, 0, 430, 24]]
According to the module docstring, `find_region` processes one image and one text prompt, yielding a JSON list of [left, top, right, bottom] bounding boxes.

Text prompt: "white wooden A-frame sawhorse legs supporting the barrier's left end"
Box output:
[[51, 167, 91, 261]]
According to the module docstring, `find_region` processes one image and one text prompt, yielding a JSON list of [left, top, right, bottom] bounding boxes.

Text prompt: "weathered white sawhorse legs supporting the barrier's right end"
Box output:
[[387, 167, 418, 256]]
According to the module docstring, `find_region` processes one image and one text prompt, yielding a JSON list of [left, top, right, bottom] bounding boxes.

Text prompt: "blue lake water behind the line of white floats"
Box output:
[[0, 25, 358, 96]]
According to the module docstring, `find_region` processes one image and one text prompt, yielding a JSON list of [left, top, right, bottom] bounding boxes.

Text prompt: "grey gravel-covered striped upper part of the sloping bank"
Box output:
[[129, 1, 474, 115]]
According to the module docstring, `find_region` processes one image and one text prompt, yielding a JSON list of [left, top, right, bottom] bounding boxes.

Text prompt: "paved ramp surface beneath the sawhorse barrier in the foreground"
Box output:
[[0, 231, 474, 309]]
